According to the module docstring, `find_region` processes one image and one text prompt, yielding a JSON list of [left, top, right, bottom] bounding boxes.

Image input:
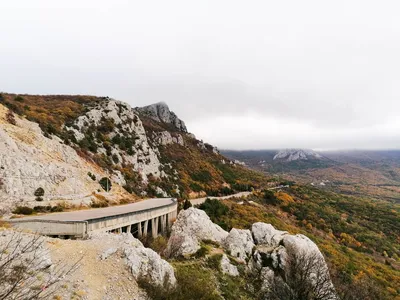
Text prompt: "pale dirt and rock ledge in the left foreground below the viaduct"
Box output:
[[0, 228, 176, 300]]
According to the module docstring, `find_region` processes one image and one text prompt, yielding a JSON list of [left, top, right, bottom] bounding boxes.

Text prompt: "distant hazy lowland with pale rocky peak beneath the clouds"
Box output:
[[221, 149, 400, 202]]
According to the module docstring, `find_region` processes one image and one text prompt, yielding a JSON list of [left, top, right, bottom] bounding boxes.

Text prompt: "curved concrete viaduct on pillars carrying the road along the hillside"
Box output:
[[10, 198, 178, 238]]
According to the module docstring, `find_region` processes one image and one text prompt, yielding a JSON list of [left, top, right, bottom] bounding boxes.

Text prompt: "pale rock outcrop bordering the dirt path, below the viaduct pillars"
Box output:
[[94, 233, 176, 286]]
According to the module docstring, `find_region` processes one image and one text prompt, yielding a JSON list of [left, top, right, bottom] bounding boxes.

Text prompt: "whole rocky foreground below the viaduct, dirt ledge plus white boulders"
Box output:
[[0, 208, 337, 300]]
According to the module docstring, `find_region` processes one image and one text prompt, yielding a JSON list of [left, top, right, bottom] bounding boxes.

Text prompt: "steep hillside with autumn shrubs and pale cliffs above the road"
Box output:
[[0, 94, 266, 211]]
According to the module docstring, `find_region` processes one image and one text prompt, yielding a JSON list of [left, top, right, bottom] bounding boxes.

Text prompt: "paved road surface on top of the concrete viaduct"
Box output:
[[14, 198, 176, 221]]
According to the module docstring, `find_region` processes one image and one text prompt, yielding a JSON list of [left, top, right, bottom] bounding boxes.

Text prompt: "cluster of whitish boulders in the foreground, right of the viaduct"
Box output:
[[167, 208, 338, 300]]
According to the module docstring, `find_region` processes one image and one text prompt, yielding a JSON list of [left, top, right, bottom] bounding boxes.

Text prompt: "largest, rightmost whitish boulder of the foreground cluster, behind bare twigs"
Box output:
[[248, 223, 337, 299]]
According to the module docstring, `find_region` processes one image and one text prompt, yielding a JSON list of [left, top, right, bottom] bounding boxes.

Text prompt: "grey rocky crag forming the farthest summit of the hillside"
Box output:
[[136, 102, 187, 132]]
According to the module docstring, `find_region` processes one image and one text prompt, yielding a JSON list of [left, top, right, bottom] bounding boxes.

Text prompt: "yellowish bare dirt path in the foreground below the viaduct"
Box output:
[[48, 239, 143, 300]]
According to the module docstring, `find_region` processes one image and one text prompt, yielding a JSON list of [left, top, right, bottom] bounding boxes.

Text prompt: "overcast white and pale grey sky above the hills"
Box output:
[[0, 0, 400, 149]]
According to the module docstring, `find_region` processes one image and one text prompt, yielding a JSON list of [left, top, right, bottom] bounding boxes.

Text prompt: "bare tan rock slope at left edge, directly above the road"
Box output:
[[0, 105, 111, 213]]
